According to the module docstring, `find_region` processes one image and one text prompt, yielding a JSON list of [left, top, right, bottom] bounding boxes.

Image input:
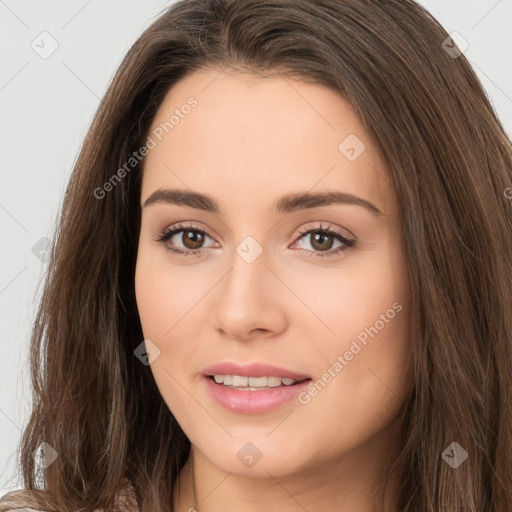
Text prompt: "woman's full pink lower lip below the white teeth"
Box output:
[[205, 377, 311, 414]]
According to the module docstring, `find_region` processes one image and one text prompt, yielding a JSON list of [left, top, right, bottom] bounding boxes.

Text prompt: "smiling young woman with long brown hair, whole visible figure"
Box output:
[[0, 0, 512, 512]]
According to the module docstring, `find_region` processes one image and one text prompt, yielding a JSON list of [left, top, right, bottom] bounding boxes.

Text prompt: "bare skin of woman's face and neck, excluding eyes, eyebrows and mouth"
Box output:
[[135, 70, 411, 512]]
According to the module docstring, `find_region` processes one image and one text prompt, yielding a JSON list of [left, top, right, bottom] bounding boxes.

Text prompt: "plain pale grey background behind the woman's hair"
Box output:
[[0, 0, 512, 495]]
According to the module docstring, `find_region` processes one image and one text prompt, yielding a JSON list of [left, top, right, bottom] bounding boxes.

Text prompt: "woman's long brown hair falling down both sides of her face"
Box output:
[[0, 0, 512, 512]]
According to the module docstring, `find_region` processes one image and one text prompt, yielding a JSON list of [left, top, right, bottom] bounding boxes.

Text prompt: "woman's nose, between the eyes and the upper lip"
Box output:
[[212, 245, 287, 341]]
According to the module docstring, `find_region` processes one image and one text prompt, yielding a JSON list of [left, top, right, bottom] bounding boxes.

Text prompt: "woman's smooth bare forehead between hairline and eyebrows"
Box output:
[[142, 69, 396, 215]]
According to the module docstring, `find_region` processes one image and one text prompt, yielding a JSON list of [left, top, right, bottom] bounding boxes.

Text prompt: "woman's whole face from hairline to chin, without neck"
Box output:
[[135, 70, 411, 476]]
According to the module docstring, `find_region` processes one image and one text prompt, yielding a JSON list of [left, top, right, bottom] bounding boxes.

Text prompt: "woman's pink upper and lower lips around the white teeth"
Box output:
[[203, 362, 311, 414]]
